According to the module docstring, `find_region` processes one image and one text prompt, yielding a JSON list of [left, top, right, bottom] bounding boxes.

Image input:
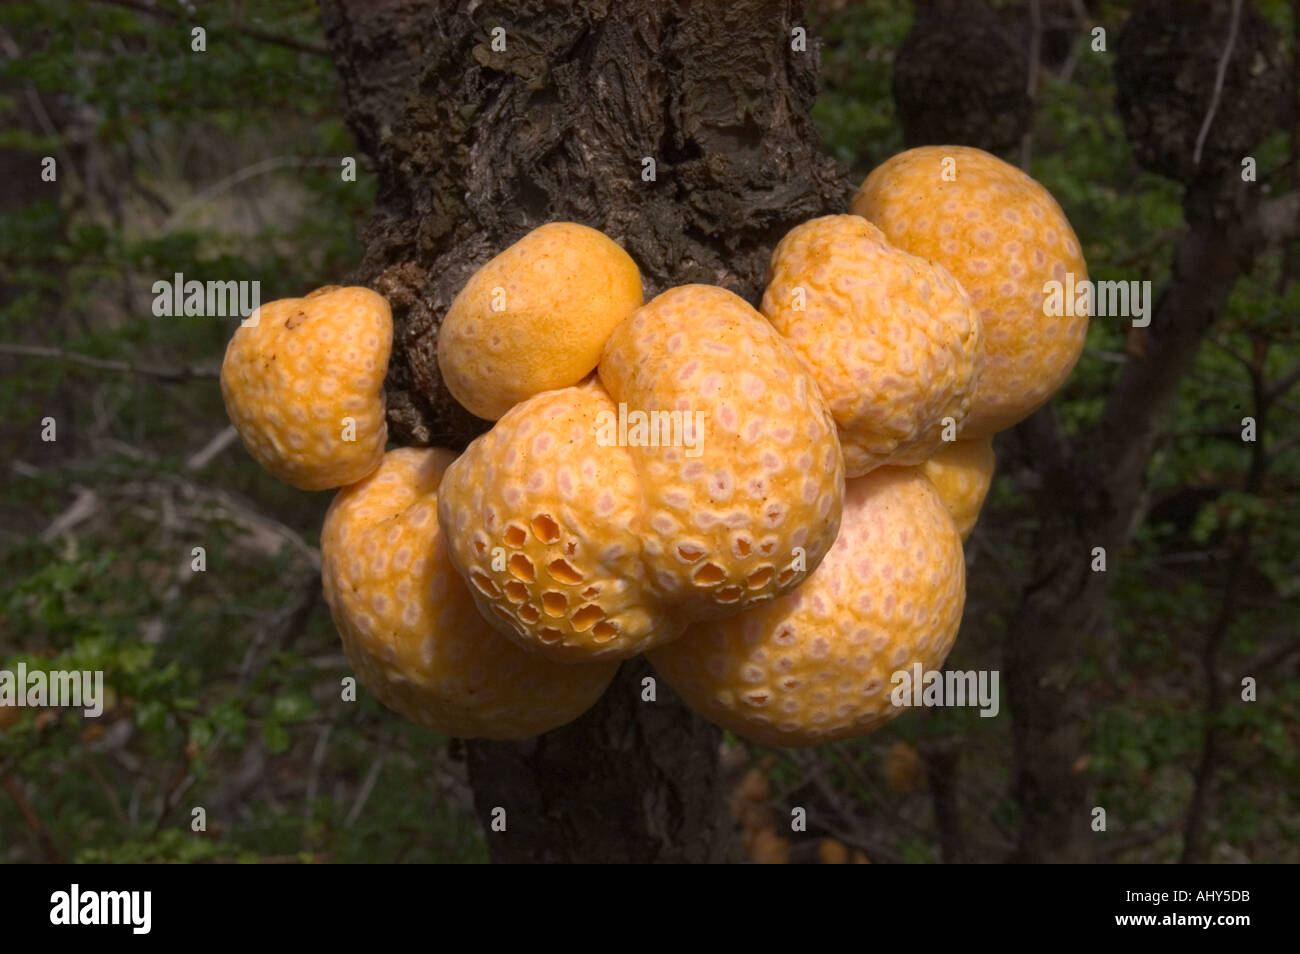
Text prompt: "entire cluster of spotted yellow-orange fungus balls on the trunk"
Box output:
[[221, 147, 1087, 746]]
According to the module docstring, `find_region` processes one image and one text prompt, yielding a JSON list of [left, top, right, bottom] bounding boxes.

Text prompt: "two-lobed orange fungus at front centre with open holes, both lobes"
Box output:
[[439, 286, 844, 660]]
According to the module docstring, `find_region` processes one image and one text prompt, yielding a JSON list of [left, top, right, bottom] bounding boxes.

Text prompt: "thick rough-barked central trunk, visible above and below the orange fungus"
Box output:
[[321, 0, 852, 862]]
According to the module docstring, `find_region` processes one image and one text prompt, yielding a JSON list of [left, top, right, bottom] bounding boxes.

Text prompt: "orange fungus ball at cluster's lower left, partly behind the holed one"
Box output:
[[321, 448, 616, 740]]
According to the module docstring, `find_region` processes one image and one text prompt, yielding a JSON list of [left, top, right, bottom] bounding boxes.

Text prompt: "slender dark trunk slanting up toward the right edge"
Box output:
[[1006, 181, 1284, 863]]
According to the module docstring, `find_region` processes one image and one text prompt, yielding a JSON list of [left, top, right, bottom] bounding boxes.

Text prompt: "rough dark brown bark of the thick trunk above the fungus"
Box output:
[[314, 0, 849, 446]]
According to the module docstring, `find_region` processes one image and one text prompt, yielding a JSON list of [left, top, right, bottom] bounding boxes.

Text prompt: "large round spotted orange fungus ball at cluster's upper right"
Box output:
[[850, 146, 1088, 438]]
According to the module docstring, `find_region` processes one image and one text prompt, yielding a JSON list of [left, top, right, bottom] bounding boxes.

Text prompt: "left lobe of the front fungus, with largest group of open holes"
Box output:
[[439, 381, 683, 660]]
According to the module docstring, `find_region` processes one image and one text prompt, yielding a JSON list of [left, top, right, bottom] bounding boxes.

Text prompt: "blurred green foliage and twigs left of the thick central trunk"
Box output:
[[0, 0, 485, 862]]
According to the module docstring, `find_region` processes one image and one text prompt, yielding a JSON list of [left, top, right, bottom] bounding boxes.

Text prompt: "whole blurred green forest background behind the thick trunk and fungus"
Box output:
[[0, 0, 1300, 863]]
